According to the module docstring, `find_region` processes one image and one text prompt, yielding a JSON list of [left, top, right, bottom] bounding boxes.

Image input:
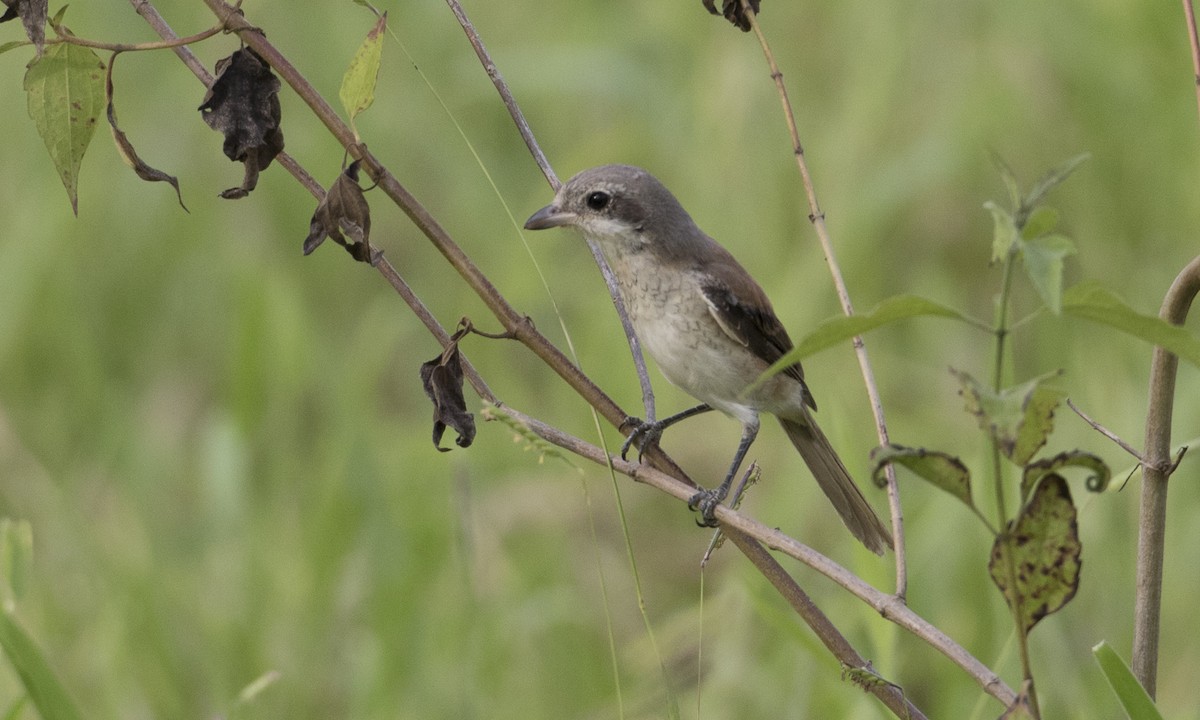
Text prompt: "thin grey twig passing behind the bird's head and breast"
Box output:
[[446, 0, 656, 422]]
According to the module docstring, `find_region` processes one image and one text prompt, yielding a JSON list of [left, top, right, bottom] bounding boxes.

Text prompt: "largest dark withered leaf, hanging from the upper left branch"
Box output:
[[199, 48, 283, 199]]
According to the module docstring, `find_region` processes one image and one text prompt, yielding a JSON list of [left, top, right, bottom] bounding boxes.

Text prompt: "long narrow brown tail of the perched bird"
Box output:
[[779, 413, 892, 554]]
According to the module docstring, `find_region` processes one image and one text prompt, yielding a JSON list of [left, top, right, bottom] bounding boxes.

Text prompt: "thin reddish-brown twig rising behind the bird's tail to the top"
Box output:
[[740, 0, 908, 600]]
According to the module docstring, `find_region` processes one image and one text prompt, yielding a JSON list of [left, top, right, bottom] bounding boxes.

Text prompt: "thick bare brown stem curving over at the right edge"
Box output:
[[1133, 257, 1200, 697]]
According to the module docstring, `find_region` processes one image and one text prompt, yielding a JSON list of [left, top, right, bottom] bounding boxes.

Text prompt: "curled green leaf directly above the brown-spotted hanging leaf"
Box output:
[[950, 368, 1064, 466]]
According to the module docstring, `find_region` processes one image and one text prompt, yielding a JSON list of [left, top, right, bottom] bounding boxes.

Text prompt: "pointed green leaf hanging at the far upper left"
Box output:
[[25, 42, 104, 215]]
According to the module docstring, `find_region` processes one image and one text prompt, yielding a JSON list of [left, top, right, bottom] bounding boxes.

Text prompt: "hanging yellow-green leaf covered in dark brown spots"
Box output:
[[988, 473, 1081, 634]]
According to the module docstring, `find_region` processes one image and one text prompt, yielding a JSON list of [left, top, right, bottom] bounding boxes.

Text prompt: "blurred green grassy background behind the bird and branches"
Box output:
[[0, 0, 1200, 719]]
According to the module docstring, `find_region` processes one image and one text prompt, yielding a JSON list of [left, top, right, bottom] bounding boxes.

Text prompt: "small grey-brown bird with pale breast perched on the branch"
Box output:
[[524, 164, 893, 554]]
